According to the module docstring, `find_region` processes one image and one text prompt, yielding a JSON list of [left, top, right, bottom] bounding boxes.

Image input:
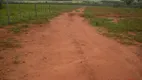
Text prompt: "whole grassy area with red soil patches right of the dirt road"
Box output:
[[84, 7, 142, 44]]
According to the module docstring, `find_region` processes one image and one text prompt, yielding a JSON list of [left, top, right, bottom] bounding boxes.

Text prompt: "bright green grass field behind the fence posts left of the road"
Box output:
[[0, 4, 76, 26]]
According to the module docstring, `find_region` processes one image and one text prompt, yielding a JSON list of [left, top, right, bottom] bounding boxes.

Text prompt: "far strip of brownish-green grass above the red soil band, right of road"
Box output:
[[87, 6, 142, 17]]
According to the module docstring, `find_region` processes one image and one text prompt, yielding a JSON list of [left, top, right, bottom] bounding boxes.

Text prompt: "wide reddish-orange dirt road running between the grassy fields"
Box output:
[[1, 9, 142, 80]]
